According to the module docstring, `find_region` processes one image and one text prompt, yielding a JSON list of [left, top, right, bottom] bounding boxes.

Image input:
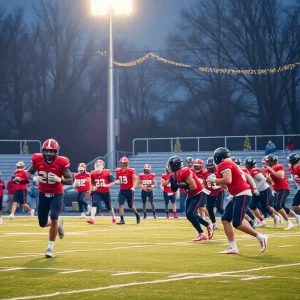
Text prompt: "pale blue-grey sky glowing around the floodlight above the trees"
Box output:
[[0, 0, 197, 50]]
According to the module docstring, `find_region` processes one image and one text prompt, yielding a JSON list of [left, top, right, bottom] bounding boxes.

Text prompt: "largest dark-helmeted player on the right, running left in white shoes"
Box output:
[[207, 147, 268, 254]]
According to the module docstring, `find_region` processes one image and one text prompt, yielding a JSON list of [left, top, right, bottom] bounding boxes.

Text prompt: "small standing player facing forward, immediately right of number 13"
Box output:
[[138, 164, 156, 219]]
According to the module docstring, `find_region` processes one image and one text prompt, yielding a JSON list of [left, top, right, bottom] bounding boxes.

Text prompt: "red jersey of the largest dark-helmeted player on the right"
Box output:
[[218, 160, 250, 196]]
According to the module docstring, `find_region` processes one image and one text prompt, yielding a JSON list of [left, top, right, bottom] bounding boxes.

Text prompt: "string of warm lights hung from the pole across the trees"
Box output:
[[114, 52, 300, 75]]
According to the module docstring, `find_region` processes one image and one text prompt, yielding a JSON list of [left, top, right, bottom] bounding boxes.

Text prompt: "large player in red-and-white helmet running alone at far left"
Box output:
[[28, 139, 73, 258]]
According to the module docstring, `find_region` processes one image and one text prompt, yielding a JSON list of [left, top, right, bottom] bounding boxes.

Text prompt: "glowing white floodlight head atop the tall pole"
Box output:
[[91, 0, 132, 15]]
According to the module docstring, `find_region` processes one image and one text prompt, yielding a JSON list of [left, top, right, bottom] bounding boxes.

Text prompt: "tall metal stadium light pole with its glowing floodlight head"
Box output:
[[91, 0, 132, 169]]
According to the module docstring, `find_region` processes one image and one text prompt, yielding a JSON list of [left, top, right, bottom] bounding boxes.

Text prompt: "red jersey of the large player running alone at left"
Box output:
[[31, 153, 70, 195]]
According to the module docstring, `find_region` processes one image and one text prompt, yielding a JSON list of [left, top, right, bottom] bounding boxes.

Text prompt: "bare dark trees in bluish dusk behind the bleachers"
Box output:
[[0, 0, 300, 166]]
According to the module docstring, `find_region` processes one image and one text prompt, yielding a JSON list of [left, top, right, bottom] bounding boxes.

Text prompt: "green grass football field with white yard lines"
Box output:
[[0, 217, 300, 300]]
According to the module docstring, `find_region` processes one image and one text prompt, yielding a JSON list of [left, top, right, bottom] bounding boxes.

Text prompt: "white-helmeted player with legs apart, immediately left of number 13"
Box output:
[[87, 159, 117, 224]]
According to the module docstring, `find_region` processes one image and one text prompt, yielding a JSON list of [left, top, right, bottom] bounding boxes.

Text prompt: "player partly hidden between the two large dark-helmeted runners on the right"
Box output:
[[203, 157, 224, 230]]
